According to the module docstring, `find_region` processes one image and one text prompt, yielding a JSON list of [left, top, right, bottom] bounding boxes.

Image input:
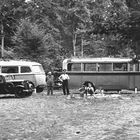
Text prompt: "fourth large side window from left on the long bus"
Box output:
[[113, 63, 128, 71]]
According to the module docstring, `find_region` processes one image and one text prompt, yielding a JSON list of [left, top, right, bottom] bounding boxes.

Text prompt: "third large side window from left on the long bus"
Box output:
[[98, 63, 112, 71]]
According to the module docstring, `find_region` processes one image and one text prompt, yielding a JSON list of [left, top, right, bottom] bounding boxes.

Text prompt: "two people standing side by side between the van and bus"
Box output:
[[46, 69, 70, 95]]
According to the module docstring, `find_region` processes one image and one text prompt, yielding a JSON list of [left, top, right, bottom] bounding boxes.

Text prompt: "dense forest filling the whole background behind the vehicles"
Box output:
[[0, 0, 140, 71]]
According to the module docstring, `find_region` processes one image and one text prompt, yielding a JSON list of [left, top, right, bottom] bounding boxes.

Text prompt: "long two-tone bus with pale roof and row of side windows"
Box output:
[[63, 57, 140, 90]]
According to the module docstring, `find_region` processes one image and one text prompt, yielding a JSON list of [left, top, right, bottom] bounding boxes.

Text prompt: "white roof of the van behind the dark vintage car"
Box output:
[[0, 60, 41, 66]]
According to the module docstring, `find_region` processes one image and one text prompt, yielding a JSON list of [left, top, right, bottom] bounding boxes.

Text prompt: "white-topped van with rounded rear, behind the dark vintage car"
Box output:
[[0, 60, 46, 92]]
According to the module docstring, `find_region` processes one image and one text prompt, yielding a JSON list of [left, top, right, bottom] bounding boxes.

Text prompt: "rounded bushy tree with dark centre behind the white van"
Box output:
[[13, 20, 59, 70]]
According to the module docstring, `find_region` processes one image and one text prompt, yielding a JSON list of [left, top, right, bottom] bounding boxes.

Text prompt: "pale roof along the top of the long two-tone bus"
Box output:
[[63, 57, 132, 63]]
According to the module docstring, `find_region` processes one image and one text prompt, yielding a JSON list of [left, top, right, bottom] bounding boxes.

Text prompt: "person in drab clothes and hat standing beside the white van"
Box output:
[[46, 72, 54, 95]]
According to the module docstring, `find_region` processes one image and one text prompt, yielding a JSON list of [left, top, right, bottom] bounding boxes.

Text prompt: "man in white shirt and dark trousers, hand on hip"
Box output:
[[59, 69, 70, 95]]
